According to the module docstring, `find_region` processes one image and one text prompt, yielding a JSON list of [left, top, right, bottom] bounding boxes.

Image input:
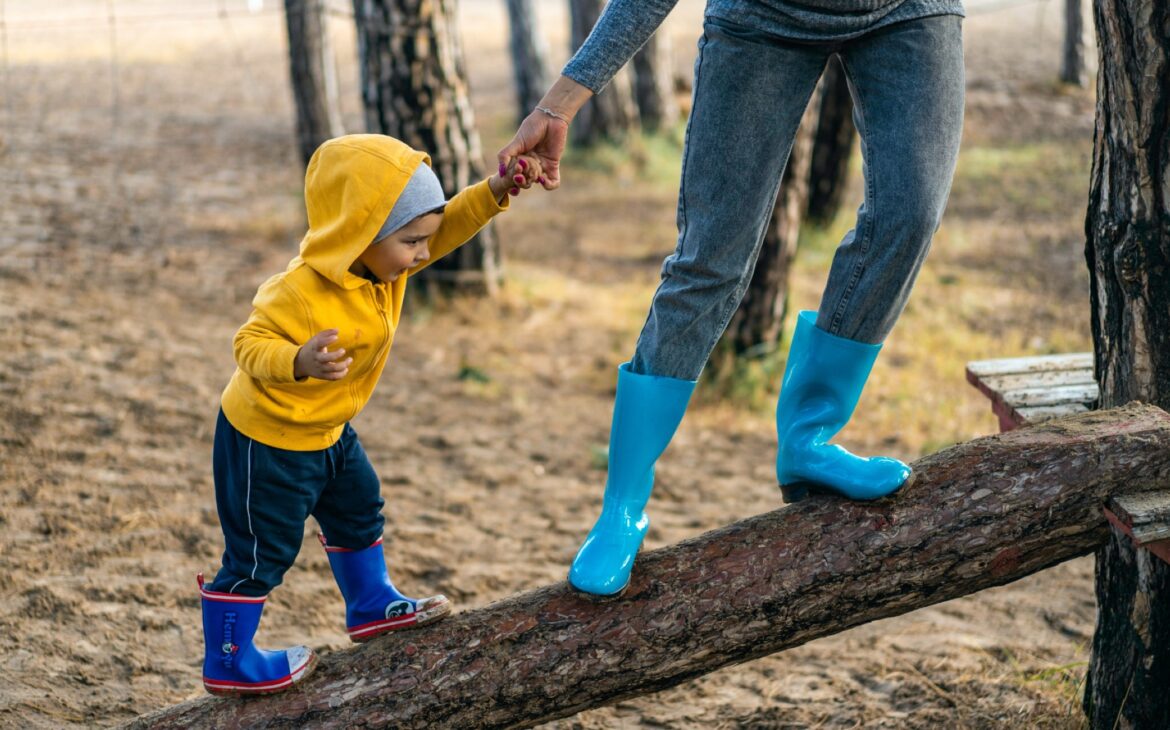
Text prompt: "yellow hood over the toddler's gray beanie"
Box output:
[[299, 135, 431, 289]]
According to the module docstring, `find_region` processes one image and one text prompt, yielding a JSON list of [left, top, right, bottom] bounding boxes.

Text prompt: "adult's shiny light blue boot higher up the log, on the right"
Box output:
[[776, 311, 910, 502]]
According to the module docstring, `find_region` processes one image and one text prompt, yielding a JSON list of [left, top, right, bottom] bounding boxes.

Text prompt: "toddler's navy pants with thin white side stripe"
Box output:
[[207, 411, 384, 595]]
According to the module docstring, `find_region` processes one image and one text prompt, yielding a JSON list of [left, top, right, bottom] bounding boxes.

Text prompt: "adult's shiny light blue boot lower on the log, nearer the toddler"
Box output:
[[569, 363, 695, 595]]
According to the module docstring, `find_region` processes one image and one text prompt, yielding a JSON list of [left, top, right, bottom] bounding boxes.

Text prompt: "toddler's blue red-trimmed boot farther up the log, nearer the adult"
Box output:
[[318, 535, 450, 642]]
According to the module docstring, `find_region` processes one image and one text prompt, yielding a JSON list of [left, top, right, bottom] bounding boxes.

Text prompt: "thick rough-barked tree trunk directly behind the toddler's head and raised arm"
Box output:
[[353, 0, 500, 294]]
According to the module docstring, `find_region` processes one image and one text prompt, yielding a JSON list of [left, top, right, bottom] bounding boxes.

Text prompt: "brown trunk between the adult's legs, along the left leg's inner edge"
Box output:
[[709, 85, 820, 362]]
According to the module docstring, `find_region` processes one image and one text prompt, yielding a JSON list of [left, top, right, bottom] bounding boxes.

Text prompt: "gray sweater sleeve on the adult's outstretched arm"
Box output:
[[562, 0, 679, 94]]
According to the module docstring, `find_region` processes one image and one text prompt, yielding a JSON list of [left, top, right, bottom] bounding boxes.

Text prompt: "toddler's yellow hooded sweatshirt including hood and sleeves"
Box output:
[[220, 135, 508, 452]]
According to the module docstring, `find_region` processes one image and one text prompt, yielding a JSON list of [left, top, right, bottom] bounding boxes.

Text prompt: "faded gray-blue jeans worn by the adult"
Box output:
[[631, 15, 964, 380]]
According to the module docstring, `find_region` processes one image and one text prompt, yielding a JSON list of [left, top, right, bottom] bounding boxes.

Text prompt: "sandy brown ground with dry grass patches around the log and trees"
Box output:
[[0, 0, 1095, 728]]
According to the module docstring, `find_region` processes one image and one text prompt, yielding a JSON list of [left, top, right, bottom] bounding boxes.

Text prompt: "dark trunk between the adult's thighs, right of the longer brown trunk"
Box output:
[[808, 56, 856, 223]]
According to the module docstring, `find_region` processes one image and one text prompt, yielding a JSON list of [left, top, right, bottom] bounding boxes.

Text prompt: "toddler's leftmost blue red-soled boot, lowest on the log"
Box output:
[[198, 573, 317, 695]]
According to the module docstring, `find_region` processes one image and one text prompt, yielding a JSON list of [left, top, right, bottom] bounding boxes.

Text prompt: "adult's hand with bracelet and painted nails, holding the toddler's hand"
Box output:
[[496, 76, 593, 190]]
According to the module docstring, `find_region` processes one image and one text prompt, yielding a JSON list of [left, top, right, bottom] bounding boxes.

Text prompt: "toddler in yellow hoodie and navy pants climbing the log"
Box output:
[[199, 135, 542, 695]]
